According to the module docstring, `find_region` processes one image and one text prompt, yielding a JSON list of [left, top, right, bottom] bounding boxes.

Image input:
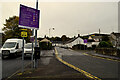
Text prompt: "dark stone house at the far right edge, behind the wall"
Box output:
[[110, 32, 120, 48]]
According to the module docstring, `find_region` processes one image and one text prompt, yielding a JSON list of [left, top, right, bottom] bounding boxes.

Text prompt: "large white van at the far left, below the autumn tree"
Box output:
[[1, 39, 26, 58]]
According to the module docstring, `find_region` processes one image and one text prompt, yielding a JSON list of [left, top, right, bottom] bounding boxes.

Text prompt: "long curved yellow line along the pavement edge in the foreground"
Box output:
[[55, 48, 101, 80]]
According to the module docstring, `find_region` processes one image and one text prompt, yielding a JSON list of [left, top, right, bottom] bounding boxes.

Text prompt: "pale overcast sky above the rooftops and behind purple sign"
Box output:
[[0, 1, 118, 37]]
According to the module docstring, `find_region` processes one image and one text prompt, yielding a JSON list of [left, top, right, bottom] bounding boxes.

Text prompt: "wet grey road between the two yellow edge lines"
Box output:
[[57, 48, 120, 80]]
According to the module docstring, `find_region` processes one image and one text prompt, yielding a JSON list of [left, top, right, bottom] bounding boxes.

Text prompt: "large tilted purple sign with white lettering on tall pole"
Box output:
[[19, 4, 40, 29]]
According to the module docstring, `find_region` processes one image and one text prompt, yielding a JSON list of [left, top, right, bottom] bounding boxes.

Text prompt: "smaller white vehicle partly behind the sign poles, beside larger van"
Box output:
[[24, 43, 35, 57]]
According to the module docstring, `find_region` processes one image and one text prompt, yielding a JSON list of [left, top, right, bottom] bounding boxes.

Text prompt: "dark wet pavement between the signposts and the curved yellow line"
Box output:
[[7, 50, 88, 80]]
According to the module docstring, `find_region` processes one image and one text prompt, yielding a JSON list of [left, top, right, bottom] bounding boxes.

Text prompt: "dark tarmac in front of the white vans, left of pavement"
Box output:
[[0, 53, 30, 78]]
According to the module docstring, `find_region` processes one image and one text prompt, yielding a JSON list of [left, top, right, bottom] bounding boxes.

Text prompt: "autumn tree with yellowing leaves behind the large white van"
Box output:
[[2, 16, 32, 42]]
